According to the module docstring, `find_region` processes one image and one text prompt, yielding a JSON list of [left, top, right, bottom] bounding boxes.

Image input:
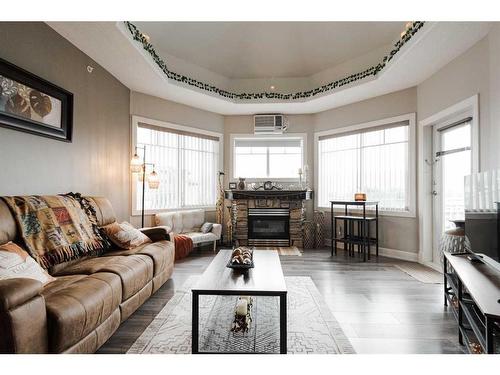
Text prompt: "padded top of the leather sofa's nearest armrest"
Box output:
[[0, 278, 43, 311]]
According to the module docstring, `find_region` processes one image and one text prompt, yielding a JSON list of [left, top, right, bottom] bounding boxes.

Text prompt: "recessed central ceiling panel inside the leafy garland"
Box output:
[[134, 22, 405, 79]]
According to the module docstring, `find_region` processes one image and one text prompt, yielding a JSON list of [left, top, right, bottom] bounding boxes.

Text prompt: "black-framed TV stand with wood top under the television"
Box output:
[[443, 253, 500, 354]]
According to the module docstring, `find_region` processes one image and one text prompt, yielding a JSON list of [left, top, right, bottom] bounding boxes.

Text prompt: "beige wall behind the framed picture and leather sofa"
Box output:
[[0, 22, 130, 220]]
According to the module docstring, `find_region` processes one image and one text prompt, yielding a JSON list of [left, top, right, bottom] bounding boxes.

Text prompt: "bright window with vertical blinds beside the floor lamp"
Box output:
[[134, 120, 221, 211]]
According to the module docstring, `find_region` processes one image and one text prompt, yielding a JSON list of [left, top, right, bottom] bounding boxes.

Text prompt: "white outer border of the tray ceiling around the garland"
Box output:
[[48, 22, 491, 115]]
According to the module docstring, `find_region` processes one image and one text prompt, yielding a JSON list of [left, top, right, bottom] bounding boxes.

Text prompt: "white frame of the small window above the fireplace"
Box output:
[[229, 133, 307, 182]]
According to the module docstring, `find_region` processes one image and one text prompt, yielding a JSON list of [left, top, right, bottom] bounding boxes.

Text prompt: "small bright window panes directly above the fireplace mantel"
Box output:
[[232, 135, 304, 180]]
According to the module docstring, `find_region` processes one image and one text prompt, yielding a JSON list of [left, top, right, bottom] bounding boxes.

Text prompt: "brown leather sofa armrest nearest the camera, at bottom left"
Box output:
[[0, 278, 49, 354]]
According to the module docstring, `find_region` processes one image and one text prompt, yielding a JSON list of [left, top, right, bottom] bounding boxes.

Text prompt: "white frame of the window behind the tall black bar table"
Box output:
[[314, 113, 417, 218]]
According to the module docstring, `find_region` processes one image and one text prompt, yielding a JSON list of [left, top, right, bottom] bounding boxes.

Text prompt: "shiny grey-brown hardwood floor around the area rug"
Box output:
[[98, 249, 463, 354]]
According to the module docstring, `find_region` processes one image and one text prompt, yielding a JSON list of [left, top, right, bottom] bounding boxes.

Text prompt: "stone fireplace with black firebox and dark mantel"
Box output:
[[225, 190, 312, 248]]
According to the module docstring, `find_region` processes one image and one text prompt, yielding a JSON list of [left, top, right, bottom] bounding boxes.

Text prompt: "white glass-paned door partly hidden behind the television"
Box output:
[[433, 118, 472, 263]]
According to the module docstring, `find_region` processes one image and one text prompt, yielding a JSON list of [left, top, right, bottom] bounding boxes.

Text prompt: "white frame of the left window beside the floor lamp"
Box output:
[[129, 115, 224, 216]]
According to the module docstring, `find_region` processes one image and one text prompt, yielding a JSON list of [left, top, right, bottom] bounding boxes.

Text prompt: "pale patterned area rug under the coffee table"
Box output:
[[127, 276, 355, 354]]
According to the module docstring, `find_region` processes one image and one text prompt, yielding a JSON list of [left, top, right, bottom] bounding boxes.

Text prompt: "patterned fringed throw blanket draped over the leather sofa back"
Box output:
[[3, 194, 105, 269]]
